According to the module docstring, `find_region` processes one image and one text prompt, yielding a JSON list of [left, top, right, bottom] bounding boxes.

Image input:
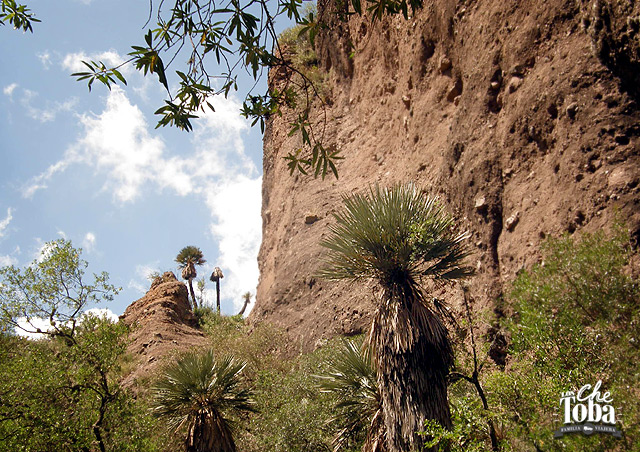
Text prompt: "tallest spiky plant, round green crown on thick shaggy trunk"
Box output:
[[321, 185, 472, 452]]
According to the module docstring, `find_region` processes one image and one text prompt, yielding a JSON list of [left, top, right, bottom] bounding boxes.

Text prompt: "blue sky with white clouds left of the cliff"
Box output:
[[0, 0, 284, 320]]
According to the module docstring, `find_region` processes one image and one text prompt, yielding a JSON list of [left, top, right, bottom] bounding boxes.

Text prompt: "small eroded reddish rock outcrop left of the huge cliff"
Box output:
[[120, 272, 207, 389]]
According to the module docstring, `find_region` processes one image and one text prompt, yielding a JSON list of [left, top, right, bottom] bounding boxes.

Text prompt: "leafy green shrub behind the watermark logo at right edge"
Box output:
[[487, 227, 640, 451]]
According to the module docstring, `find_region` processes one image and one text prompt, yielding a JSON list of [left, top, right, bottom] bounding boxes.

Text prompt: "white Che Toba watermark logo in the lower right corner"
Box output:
[[553, 380, 621, 438]]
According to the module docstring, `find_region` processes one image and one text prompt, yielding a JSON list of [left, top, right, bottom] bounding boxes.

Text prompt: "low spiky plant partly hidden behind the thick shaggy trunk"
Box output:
[[318, 340, 386, 452]]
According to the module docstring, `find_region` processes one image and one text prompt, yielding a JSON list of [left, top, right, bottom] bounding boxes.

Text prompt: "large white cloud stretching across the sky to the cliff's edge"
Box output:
[[23, 87, 262, 309]]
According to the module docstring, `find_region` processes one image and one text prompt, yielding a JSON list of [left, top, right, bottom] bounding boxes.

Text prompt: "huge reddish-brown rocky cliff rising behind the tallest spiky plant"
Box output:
[[250, 0, 640, 347]]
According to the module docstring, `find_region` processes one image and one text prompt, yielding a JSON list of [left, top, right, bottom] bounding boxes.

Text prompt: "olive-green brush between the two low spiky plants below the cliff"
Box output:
[[196, 310, 336, 452]]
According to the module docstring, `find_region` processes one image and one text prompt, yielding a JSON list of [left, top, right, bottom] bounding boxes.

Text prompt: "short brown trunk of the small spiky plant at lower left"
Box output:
[[185, 411, 236, 452]]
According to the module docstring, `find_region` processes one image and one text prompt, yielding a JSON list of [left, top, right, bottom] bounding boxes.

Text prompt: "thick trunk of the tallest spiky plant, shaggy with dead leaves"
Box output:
[[369, 281, 453, 452]]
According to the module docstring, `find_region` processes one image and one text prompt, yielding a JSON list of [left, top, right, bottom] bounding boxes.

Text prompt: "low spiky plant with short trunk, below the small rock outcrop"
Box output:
[[152, 350, 254, 452]]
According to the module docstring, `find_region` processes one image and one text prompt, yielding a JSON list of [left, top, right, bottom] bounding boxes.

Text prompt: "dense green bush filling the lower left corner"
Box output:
[[0, 317, 159, 452]]
